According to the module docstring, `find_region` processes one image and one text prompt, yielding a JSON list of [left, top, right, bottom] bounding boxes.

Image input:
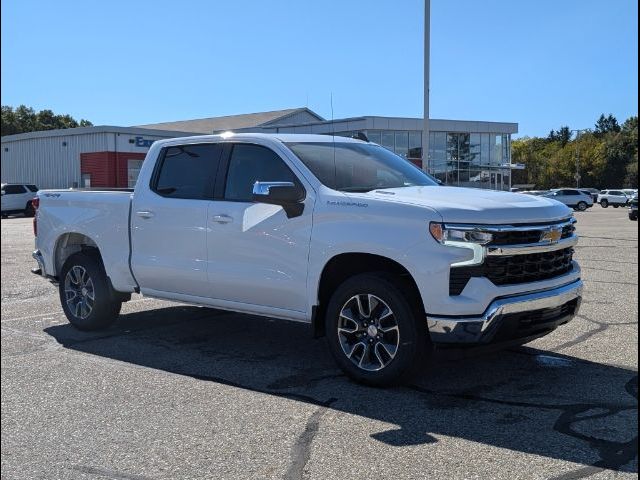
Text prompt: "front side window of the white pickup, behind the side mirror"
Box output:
[[224, 143, 299, 202]]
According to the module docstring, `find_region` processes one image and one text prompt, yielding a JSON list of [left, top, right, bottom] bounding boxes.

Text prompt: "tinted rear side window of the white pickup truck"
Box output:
[[152, 144, 222, 200]]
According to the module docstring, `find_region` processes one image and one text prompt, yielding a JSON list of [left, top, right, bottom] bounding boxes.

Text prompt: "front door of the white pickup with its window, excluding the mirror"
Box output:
[[208, 143, 314, 312]]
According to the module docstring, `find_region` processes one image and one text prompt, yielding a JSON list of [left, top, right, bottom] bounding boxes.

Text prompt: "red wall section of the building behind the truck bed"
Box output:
[[80, 152, 146, 188]]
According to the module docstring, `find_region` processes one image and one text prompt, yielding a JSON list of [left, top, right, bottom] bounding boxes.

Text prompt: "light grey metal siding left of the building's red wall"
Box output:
[[0, 133, 114, 188]]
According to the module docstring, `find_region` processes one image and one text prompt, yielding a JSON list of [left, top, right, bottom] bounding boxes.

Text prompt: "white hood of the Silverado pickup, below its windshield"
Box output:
[[364, 186, 572, 225]]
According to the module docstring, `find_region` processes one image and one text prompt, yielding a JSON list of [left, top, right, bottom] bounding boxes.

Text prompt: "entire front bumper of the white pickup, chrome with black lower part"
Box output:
[[427, 280, 583, 345]]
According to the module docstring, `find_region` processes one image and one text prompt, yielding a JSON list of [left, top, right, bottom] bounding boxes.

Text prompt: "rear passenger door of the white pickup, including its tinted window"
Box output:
[[131, 144, 222, 296]]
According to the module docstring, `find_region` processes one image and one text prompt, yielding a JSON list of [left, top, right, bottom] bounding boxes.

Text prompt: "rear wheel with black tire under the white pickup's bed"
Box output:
[[58, 250, 122, 330]]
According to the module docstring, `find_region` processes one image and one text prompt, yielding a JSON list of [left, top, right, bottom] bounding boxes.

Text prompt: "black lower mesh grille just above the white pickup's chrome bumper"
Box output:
[[449, 248, 574, 296]]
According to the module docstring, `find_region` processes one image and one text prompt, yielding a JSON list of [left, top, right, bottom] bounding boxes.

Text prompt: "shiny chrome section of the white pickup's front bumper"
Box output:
[[427, 280, 584, 344]]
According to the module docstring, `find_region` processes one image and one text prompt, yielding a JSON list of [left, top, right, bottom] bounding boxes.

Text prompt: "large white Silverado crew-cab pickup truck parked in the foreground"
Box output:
[[33, 134, 582, 385]]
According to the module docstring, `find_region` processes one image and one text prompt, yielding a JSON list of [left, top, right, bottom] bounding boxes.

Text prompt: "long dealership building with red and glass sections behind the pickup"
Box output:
[[1, 108, 518, 190]]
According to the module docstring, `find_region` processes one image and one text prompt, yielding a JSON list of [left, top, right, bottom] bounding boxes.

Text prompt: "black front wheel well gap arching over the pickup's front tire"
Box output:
[[311, 252, 424, 338]]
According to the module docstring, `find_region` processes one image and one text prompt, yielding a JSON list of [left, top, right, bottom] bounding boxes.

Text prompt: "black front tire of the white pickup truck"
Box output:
[[325, 273, 431, 387]]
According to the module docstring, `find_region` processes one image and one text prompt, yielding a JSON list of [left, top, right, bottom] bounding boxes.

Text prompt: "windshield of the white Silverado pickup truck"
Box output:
[[286, 142, 438, 192]]
